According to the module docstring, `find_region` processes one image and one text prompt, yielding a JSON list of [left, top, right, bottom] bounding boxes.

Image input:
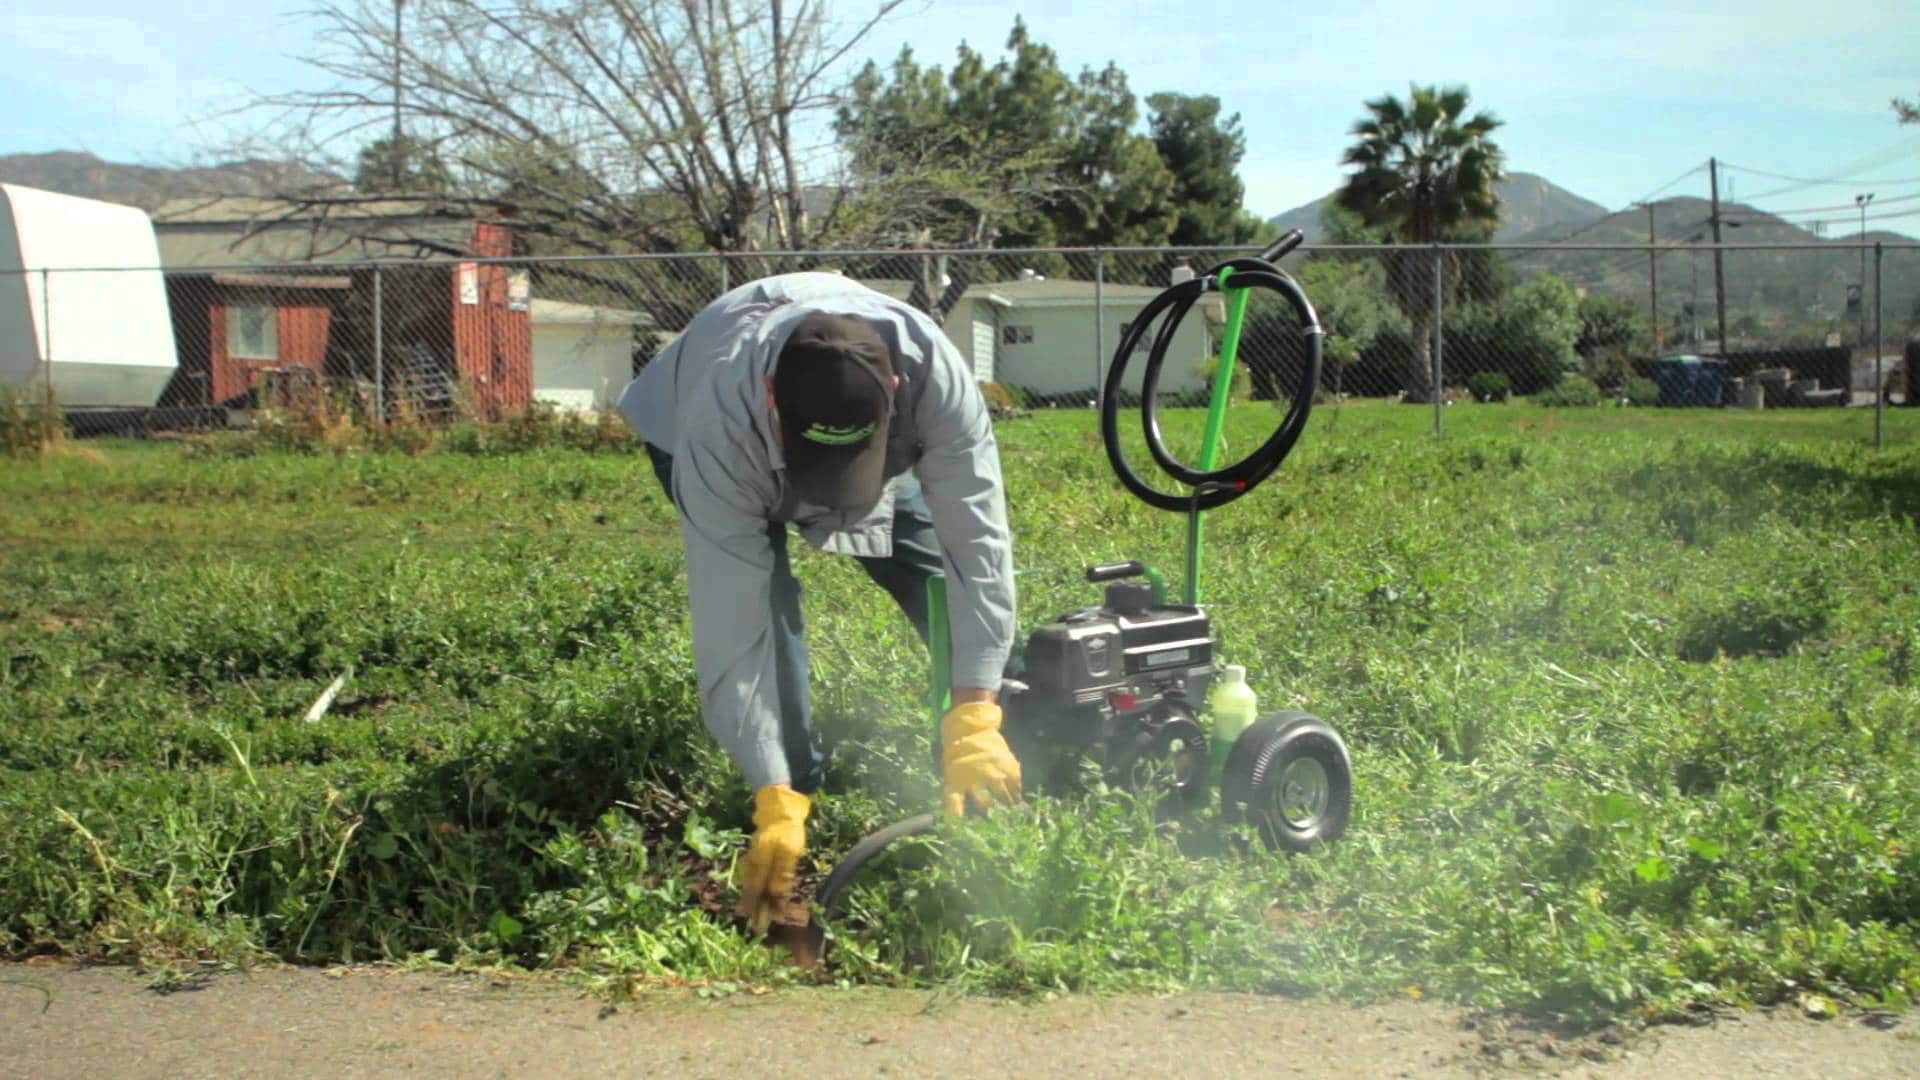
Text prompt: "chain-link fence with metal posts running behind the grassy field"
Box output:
[[0, 242, 1920, 438]]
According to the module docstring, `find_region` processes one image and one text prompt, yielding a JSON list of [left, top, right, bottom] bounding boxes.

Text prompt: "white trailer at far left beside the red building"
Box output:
[[0, 184, 179, 407]]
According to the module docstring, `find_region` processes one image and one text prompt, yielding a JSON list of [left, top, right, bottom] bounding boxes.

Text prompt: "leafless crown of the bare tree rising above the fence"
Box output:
[[220, 0, 904, 252]]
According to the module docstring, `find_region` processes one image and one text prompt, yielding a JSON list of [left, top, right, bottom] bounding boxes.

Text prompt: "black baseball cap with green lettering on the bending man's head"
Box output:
[[774, 313, 893, 509]]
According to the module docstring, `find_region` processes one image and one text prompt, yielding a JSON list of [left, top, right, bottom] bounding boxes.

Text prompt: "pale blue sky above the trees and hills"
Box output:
[[0, 0, 1920, 234]]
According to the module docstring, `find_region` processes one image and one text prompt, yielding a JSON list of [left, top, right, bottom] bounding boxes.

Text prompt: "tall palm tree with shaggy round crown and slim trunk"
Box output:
[[1334, 86, 1505, 402]]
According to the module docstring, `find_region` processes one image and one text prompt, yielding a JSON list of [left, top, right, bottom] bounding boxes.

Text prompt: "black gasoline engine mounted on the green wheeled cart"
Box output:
[[1002, 563, 1213, 809]]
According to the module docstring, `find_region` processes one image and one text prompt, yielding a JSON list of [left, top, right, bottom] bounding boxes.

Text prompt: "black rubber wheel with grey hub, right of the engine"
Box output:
[[1221, 709, 1354, 855]]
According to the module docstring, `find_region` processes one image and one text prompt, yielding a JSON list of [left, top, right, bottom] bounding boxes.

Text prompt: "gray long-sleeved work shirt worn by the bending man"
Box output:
[[620, 273, 1014, 790]]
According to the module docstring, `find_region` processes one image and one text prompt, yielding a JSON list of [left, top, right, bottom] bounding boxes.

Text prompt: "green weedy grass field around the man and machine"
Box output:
[[0, 405, 1920, 1015]]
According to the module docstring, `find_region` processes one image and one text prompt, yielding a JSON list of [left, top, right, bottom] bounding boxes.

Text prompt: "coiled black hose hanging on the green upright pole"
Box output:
[[1100, 229, 1325, 513]]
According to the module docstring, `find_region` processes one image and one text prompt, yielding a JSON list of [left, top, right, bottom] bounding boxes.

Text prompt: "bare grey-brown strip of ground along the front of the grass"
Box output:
[[0, 963, 1920, 1080]]
